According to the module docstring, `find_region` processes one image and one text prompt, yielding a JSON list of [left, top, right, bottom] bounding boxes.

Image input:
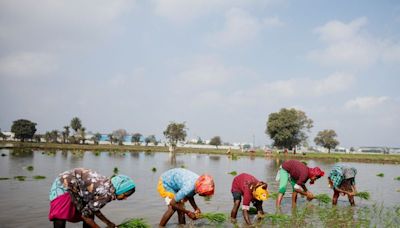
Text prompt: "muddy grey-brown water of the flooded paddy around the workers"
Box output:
[[0, 150, 400, 227]]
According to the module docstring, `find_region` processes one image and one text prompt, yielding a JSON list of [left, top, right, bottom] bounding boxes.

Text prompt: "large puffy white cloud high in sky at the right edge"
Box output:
[[308, 17, 400, 70]]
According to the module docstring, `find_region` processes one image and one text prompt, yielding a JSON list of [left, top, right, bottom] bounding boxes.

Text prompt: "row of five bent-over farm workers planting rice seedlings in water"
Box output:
[[49, 160, 357, 228]]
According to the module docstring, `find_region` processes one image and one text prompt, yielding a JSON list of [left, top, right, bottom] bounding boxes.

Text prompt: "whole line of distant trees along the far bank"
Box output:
[[0, 108, 339, 152]]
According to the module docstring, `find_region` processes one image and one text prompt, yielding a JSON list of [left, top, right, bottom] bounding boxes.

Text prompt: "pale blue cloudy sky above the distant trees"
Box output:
[[0, 0, 400, 147]]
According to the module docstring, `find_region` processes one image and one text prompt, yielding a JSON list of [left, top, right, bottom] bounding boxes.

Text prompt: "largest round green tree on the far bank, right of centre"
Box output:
[[265, 108, 313, 149]]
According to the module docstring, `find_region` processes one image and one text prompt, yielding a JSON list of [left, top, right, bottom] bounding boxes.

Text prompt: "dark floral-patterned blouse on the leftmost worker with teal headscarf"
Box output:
[[59, 168, 116, 217]]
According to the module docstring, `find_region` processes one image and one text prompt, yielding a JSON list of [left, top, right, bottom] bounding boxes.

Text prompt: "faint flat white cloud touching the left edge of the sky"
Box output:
[[0, 52, 58, 77]]
